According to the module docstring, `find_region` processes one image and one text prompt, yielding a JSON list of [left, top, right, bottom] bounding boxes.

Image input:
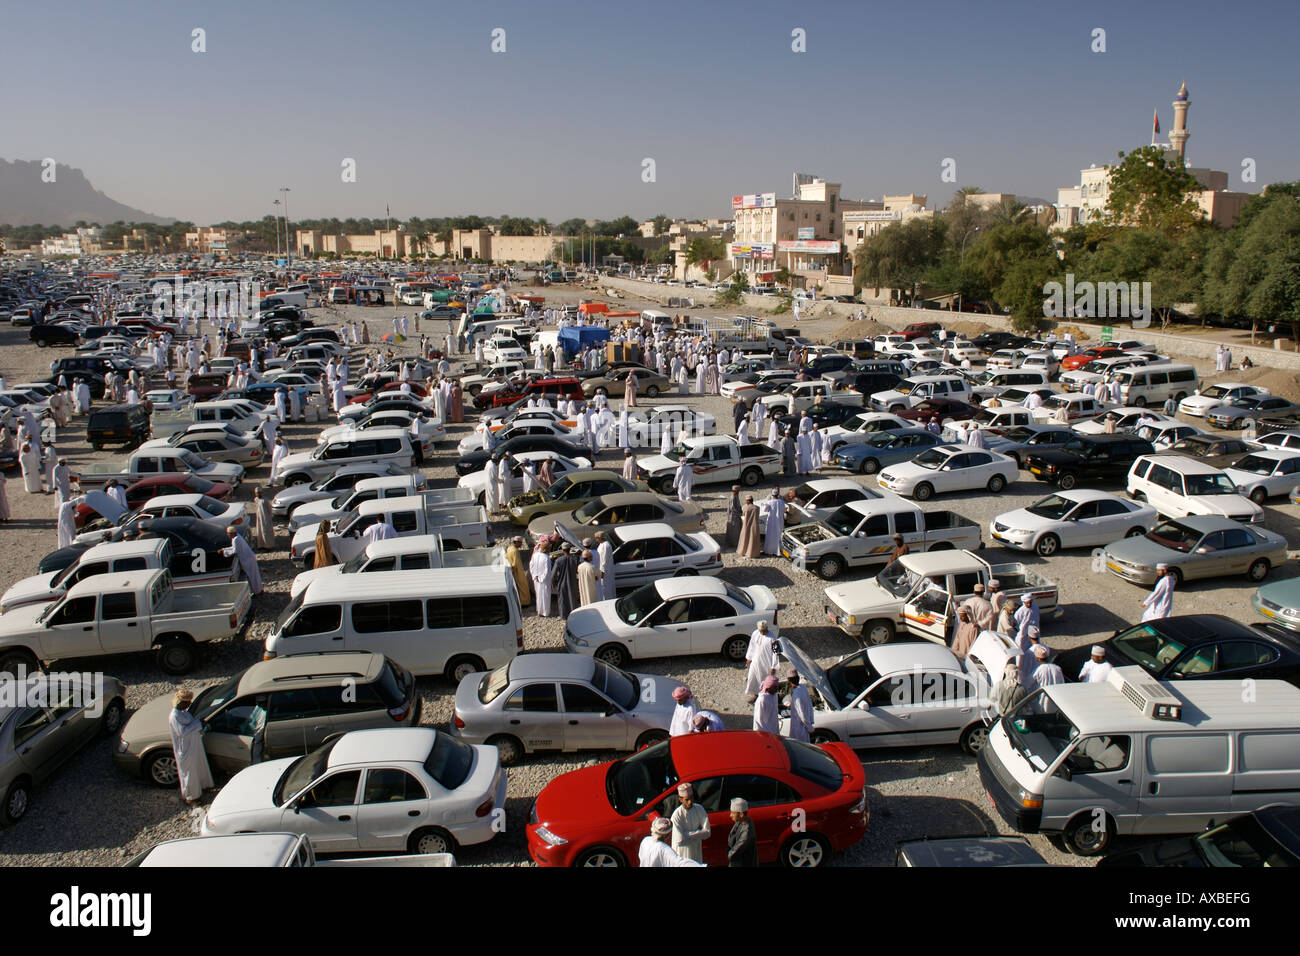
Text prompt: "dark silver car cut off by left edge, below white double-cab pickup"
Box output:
[[0, 674, 126, 825]]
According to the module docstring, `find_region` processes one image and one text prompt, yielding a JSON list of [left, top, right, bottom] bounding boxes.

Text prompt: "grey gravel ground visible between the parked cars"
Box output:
[[0, 289, 1300, 866]]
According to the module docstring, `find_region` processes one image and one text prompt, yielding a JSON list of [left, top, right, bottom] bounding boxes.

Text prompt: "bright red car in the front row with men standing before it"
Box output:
[[528, 731, 868, 866]]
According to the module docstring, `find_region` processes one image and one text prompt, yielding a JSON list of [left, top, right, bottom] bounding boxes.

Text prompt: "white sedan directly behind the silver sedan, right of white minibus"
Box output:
[[564, 578, 779, 667]]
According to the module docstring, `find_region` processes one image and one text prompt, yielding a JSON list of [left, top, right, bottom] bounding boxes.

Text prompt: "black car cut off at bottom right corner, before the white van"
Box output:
[[1097, 804, 1300, 869]]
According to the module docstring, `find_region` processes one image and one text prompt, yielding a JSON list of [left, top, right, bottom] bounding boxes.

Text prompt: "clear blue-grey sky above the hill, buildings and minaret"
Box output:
[[0, 0, 1300, 224]]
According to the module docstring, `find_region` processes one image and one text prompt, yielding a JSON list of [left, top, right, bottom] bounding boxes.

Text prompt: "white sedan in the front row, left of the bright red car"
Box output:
[[200, 728, 506, 853]]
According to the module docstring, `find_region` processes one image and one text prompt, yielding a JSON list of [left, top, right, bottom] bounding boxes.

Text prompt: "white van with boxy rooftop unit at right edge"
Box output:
[[979, 666, 1300, 856]]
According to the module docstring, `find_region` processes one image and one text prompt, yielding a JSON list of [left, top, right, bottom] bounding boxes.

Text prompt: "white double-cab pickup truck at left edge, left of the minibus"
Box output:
[[0, 570, 252, 674]]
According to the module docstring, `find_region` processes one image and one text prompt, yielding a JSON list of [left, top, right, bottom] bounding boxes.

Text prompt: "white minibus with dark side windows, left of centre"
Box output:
[[263, 564, 524, 683]]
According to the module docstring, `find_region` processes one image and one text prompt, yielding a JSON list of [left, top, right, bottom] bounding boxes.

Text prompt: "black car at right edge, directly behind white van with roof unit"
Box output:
[[1056, 614, 1300, 685]]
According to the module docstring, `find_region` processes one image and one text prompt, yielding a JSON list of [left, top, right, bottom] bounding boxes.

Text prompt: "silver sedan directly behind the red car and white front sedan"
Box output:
[[451, 654, 683, 766]]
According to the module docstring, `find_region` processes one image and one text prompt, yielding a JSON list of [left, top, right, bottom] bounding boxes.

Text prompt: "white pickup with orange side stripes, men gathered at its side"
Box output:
[[826, 551, 1062, 645]]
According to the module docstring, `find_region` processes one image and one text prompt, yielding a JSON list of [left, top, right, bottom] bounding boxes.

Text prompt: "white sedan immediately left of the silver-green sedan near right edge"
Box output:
[[989, 488, 1157, 558]]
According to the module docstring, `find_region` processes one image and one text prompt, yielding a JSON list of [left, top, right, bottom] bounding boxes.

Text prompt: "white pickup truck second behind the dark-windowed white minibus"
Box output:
[[289, 494, 491, 570]]
